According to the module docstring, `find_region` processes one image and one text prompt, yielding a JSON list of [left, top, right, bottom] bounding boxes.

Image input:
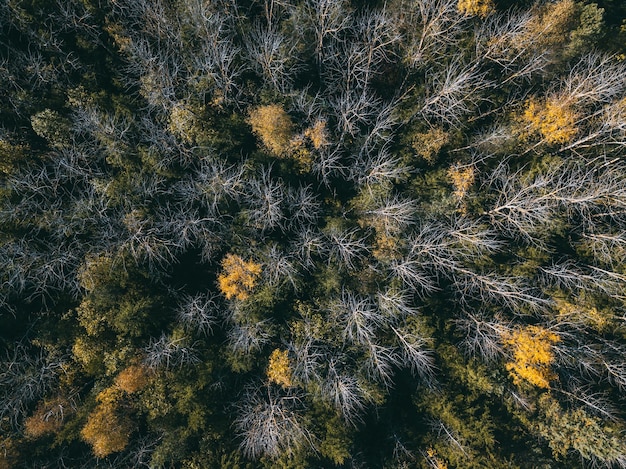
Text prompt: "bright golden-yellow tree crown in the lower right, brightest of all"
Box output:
[[502, 326, 561, 389]]
